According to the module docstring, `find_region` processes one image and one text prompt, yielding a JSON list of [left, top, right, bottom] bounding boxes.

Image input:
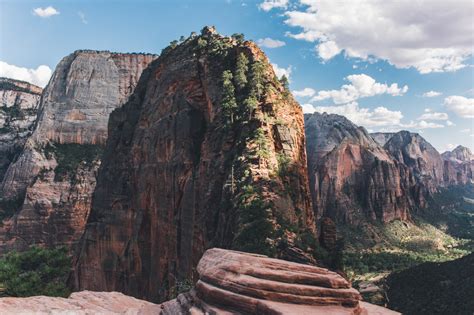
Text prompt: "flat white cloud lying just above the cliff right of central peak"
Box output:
[[314, 102, 403, 128]]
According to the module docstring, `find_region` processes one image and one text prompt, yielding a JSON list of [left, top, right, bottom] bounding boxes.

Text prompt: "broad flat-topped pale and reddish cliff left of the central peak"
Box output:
[[0, 51, 156, 253]]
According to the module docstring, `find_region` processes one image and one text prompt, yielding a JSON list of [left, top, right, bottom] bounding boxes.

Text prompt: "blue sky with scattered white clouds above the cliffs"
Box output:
[[0, 0, 474, 152]]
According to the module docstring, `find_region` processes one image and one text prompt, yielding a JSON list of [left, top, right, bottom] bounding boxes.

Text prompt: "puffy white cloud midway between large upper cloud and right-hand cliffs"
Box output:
[[312, 74, 408, 104]]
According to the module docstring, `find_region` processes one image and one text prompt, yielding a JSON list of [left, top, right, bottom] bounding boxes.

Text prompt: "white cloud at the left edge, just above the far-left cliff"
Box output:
[[0, 61, 52, 87]]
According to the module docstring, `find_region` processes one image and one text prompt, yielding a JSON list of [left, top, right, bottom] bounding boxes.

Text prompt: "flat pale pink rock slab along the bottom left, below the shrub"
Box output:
[[0, 291, 161, 315]]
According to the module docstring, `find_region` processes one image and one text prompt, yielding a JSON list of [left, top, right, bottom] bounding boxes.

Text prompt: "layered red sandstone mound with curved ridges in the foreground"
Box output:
[[162, 248, 397, 315]]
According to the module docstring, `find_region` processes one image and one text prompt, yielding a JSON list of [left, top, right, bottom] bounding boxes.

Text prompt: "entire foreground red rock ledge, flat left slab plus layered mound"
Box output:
[[0, 248, 399, 315]]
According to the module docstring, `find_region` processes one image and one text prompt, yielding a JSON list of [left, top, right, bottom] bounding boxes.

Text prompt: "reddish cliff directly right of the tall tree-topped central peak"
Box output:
[[305, 113, 413, 224]]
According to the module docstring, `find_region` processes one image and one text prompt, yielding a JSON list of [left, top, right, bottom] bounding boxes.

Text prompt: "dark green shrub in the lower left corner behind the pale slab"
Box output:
[[0, 246, 71, 297]]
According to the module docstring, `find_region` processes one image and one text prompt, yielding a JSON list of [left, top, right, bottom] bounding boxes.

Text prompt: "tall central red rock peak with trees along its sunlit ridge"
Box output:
[[74, 28, 315, 301]]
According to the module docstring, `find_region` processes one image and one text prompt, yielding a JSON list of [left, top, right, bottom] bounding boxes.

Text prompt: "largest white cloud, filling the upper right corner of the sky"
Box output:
[[284, 0, 474, 73]]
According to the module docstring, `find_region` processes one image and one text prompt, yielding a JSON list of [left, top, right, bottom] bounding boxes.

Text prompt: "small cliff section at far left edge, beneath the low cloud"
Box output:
[[0, 78, 42, 182]]
